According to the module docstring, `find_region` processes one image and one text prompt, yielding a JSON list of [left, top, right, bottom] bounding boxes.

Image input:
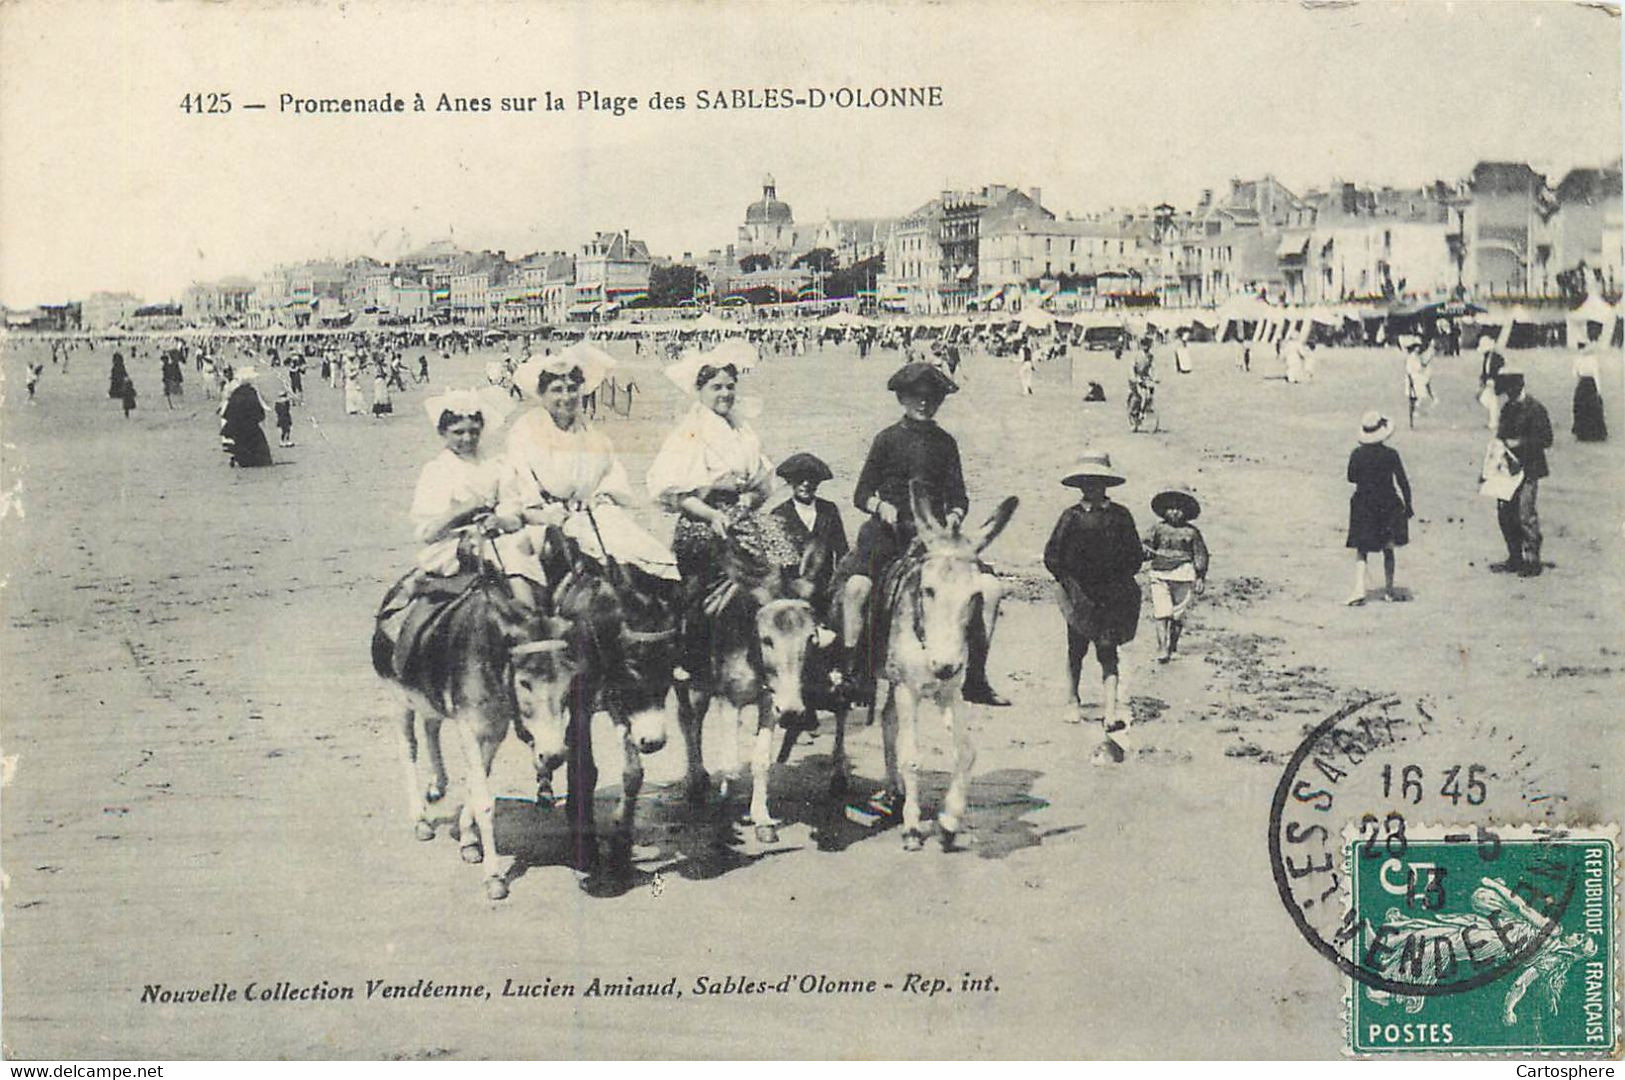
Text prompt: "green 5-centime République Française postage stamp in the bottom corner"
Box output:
[[1339, 822, 1620, 1056]]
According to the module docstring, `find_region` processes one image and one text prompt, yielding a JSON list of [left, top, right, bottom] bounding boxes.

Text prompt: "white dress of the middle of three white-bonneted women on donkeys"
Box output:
[[502, 409, 678, 581]]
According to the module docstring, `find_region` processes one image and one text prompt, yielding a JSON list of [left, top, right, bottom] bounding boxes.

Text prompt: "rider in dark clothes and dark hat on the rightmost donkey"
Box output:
[[840, 364, 1009, 705]]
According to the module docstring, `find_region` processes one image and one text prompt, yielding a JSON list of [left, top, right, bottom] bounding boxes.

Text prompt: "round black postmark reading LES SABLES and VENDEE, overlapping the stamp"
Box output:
[[1269, 697, 1592, 1013]]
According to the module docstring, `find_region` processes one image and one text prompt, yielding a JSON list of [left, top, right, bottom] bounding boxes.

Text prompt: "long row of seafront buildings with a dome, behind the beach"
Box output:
[[28, 162, 1625, 330]]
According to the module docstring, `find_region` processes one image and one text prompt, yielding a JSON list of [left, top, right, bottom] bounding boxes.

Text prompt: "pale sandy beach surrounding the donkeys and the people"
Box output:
[[0, 332, 1625, 1059]]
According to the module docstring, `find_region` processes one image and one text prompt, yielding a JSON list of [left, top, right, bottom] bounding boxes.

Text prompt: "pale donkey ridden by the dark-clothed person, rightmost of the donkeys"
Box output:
[[830, 484, 1017, 851]]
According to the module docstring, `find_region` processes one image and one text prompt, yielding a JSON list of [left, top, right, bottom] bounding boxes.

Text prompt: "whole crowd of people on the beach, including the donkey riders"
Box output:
[[12, 306, 1607, 740]]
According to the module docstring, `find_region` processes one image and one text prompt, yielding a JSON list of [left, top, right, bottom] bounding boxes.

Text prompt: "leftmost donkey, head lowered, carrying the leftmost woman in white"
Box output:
[[372, 573, 580, 900]]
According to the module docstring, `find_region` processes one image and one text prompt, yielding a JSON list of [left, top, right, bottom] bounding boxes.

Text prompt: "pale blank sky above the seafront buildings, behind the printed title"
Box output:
[[0, 0, 1622, 307]]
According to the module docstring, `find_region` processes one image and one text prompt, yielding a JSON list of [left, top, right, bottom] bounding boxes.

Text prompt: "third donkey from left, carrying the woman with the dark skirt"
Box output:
[[678, 549, 819, 843]]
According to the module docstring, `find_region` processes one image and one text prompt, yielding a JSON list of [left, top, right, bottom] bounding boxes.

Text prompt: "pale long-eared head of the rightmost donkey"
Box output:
[[899, 484, 1017, 682]]
